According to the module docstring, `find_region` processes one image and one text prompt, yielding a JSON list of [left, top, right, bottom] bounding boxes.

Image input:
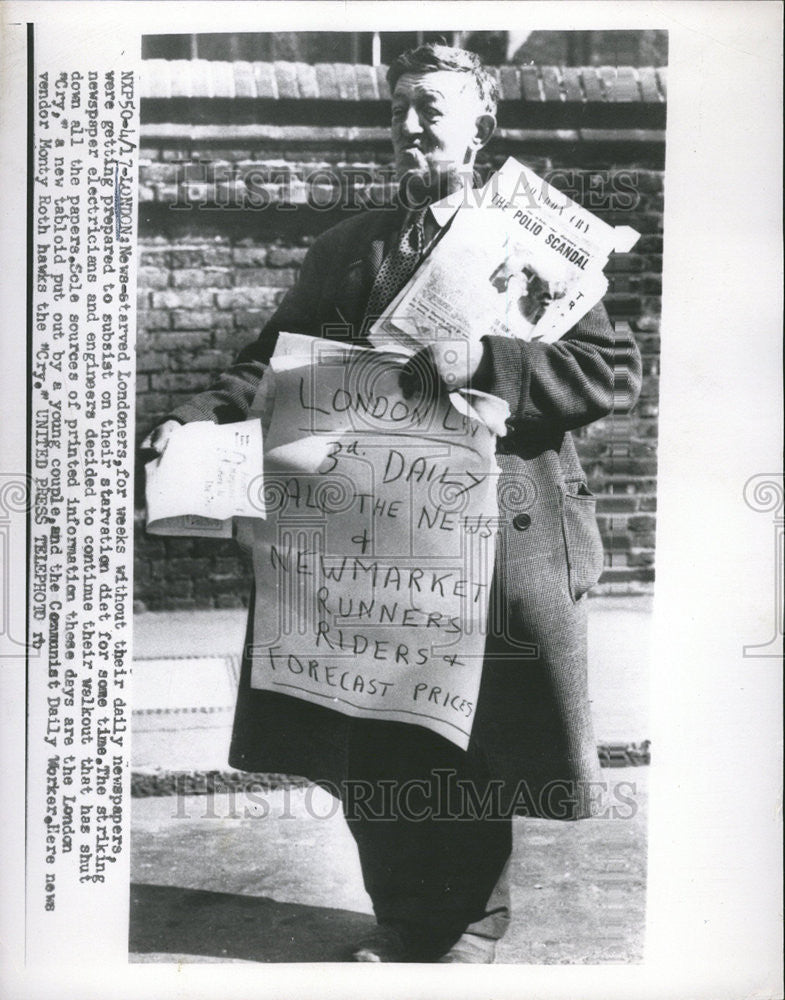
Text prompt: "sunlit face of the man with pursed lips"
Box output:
[[392, 70, 494, 197]]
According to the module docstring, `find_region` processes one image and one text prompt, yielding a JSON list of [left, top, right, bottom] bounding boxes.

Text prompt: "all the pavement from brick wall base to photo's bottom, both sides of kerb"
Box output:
[[129, 597, 651, 964]]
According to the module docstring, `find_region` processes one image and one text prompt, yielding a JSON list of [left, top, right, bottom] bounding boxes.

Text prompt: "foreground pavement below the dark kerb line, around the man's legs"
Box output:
[[129, 768, 646, 964]]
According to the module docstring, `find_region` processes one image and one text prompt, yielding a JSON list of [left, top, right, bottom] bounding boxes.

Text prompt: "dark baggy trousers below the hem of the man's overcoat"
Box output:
[[342, 719, 512, 958]]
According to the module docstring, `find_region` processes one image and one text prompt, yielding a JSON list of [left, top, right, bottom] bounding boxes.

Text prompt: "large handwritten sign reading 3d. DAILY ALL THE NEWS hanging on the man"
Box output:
[[242, 335, 497, 749]]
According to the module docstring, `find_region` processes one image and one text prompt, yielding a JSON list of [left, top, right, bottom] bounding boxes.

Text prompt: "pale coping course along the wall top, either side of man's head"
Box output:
[[141, 59, 667, 104]]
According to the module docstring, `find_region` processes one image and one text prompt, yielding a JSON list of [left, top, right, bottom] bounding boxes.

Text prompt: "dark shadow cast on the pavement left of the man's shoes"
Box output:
[[128, 883, 376, 962]]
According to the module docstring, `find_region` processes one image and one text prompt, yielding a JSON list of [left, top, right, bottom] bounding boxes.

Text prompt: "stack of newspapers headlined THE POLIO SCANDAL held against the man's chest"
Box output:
[[370, 157, 639, 353]]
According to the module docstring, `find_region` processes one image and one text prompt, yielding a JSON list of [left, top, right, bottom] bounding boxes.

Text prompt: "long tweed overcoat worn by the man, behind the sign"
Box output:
[[172, 210, 640, 819]]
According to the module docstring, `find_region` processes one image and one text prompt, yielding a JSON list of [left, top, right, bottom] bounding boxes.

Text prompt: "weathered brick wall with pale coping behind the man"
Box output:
[[135, 60, 665, 609]]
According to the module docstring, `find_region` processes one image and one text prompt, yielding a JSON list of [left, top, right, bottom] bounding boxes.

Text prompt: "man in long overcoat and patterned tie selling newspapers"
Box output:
[[145, 45, 640, 962]]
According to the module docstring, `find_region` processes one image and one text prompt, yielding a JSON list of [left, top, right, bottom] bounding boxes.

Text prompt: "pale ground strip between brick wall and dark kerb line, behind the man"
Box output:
[[132, 596, 651, 770]]
